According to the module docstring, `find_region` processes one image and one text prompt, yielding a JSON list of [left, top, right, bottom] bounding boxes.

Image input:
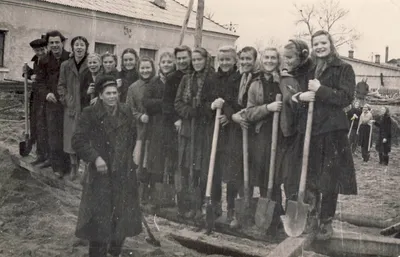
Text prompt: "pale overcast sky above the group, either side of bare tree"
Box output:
[[178, 0, 400, 61]]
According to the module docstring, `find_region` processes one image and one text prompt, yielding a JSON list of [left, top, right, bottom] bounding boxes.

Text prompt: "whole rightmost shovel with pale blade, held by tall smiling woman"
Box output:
[[281, 102, 314, 237]]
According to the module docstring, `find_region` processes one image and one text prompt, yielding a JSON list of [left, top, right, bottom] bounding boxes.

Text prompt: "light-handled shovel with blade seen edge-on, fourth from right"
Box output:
[[206, 109, 221, 234]]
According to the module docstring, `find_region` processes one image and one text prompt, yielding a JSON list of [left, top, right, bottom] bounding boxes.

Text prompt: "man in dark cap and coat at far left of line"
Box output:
[[22, 39, 49, 166]]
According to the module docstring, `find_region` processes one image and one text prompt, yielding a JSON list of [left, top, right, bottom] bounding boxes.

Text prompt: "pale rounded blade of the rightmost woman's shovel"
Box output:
[[281, 201, 309, 237]]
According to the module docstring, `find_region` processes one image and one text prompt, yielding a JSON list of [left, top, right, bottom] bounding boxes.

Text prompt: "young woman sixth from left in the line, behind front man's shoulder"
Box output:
[[118, 48, 139, 103]]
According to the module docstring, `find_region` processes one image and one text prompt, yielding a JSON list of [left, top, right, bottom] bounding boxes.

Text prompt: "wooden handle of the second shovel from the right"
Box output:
[[267, 94, 282, 199]]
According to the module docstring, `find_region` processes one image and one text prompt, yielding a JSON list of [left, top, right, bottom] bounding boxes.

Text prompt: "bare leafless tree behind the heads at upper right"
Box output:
[[294, 0, 361, 48]]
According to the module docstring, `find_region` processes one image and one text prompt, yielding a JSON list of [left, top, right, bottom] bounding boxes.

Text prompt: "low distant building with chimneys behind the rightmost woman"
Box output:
[[341, 50, 400, 90]]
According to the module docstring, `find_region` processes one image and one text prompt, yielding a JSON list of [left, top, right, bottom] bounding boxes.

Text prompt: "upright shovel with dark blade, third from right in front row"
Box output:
[[235, 128, 251, 226]]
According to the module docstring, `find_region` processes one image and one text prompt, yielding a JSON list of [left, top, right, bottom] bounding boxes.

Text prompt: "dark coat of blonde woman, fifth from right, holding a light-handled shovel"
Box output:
[[212, 68, 244, 185]]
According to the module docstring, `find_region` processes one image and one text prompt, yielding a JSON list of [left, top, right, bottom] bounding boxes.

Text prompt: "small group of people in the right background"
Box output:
[[347, 101, 392, 163]]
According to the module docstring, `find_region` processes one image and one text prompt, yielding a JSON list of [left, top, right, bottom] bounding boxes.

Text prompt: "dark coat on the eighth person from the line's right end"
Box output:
[[143, 77, 166, 173]]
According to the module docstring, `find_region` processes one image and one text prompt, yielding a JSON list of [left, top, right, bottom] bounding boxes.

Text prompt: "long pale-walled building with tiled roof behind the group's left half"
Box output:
[[0, 0, 238, 80]]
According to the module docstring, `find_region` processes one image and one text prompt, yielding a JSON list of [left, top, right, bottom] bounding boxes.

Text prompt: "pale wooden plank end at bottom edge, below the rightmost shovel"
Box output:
[[268, 234, 315, 257]]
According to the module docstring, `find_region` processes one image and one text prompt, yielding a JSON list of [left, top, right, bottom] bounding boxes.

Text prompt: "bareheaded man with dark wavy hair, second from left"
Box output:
[[40, 31, 70, 174]]
